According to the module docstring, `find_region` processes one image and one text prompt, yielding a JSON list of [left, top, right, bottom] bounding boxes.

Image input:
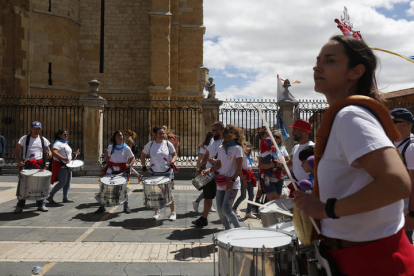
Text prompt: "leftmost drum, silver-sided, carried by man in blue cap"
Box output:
[[16, 169, 52, 200]]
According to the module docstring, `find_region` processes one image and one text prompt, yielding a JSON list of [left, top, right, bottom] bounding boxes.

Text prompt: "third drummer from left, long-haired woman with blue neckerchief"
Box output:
[[95, 130, 135, 214]]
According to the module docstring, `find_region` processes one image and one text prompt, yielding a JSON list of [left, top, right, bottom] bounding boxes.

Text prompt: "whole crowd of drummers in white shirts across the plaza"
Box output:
[[4, 36, 414, 275]]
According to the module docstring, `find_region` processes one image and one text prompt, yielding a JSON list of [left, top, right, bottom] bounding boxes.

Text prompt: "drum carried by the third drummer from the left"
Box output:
[[95, 174, 128, 206]]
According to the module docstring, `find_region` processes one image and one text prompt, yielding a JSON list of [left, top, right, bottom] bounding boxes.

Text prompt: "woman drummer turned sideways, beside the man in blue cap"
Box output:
[[46, 129, 79, 204]]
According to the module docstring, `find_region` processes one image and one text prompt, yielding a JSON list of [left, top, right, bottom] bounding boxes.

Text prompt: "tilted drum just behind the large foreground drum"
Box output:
[[259, 198, 293, 227]]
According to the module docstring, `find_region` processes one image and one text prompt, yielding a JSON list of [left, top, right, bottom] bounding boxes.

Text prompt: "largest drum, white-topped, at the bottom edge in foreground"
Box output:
[[213, 228, 297, 276]]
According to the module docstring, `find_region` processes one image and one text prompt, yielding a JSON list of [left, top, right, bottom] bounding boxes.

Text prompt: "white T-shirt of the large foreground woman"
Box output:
[[318, 106, 404, 241]]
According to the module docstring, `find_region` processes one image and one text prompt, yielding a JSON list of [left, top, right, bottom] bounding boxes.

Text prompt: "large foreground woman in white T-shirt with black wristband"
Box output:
[[294, 36, 414, 276]]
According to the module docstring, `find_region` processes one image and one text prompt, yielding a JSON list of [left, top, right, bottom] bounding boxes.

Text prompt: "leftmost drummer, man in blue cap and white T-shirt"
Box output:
[[14, 121, 52, 214]]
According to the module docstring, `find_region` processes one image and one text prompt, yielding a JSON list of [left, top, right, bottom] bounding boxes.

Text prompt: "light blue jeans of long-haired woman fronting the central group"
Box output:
[[216, 189, 240, 230]]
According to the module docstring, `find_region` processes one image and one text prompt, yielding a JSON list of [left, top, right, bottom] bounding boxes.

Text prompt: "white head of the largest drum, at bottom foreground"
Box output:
[[217, 228, 292, 248]]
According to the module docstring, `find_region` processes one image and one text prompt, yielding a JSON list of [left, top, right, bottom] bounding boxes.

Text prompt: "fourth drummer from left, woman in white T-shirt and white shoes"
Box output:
[[141, 127, 177, 221]]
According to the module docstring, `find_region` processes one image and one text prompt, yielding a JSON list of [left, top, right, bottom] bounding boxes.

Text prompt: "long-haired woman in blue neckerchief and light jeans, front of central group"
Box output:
[[202, 125, 245, 230]]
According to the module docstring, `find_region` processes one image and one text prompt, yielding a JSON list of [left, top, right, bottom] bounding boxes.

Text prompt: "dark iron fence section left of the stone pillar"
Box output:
[[0, 95, 83, 163]]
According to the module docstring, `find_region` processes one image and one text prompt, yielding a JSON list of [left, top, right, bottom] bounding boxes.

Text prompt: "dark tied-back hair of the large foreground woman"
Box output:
[[331, 35, 377, 99]]
